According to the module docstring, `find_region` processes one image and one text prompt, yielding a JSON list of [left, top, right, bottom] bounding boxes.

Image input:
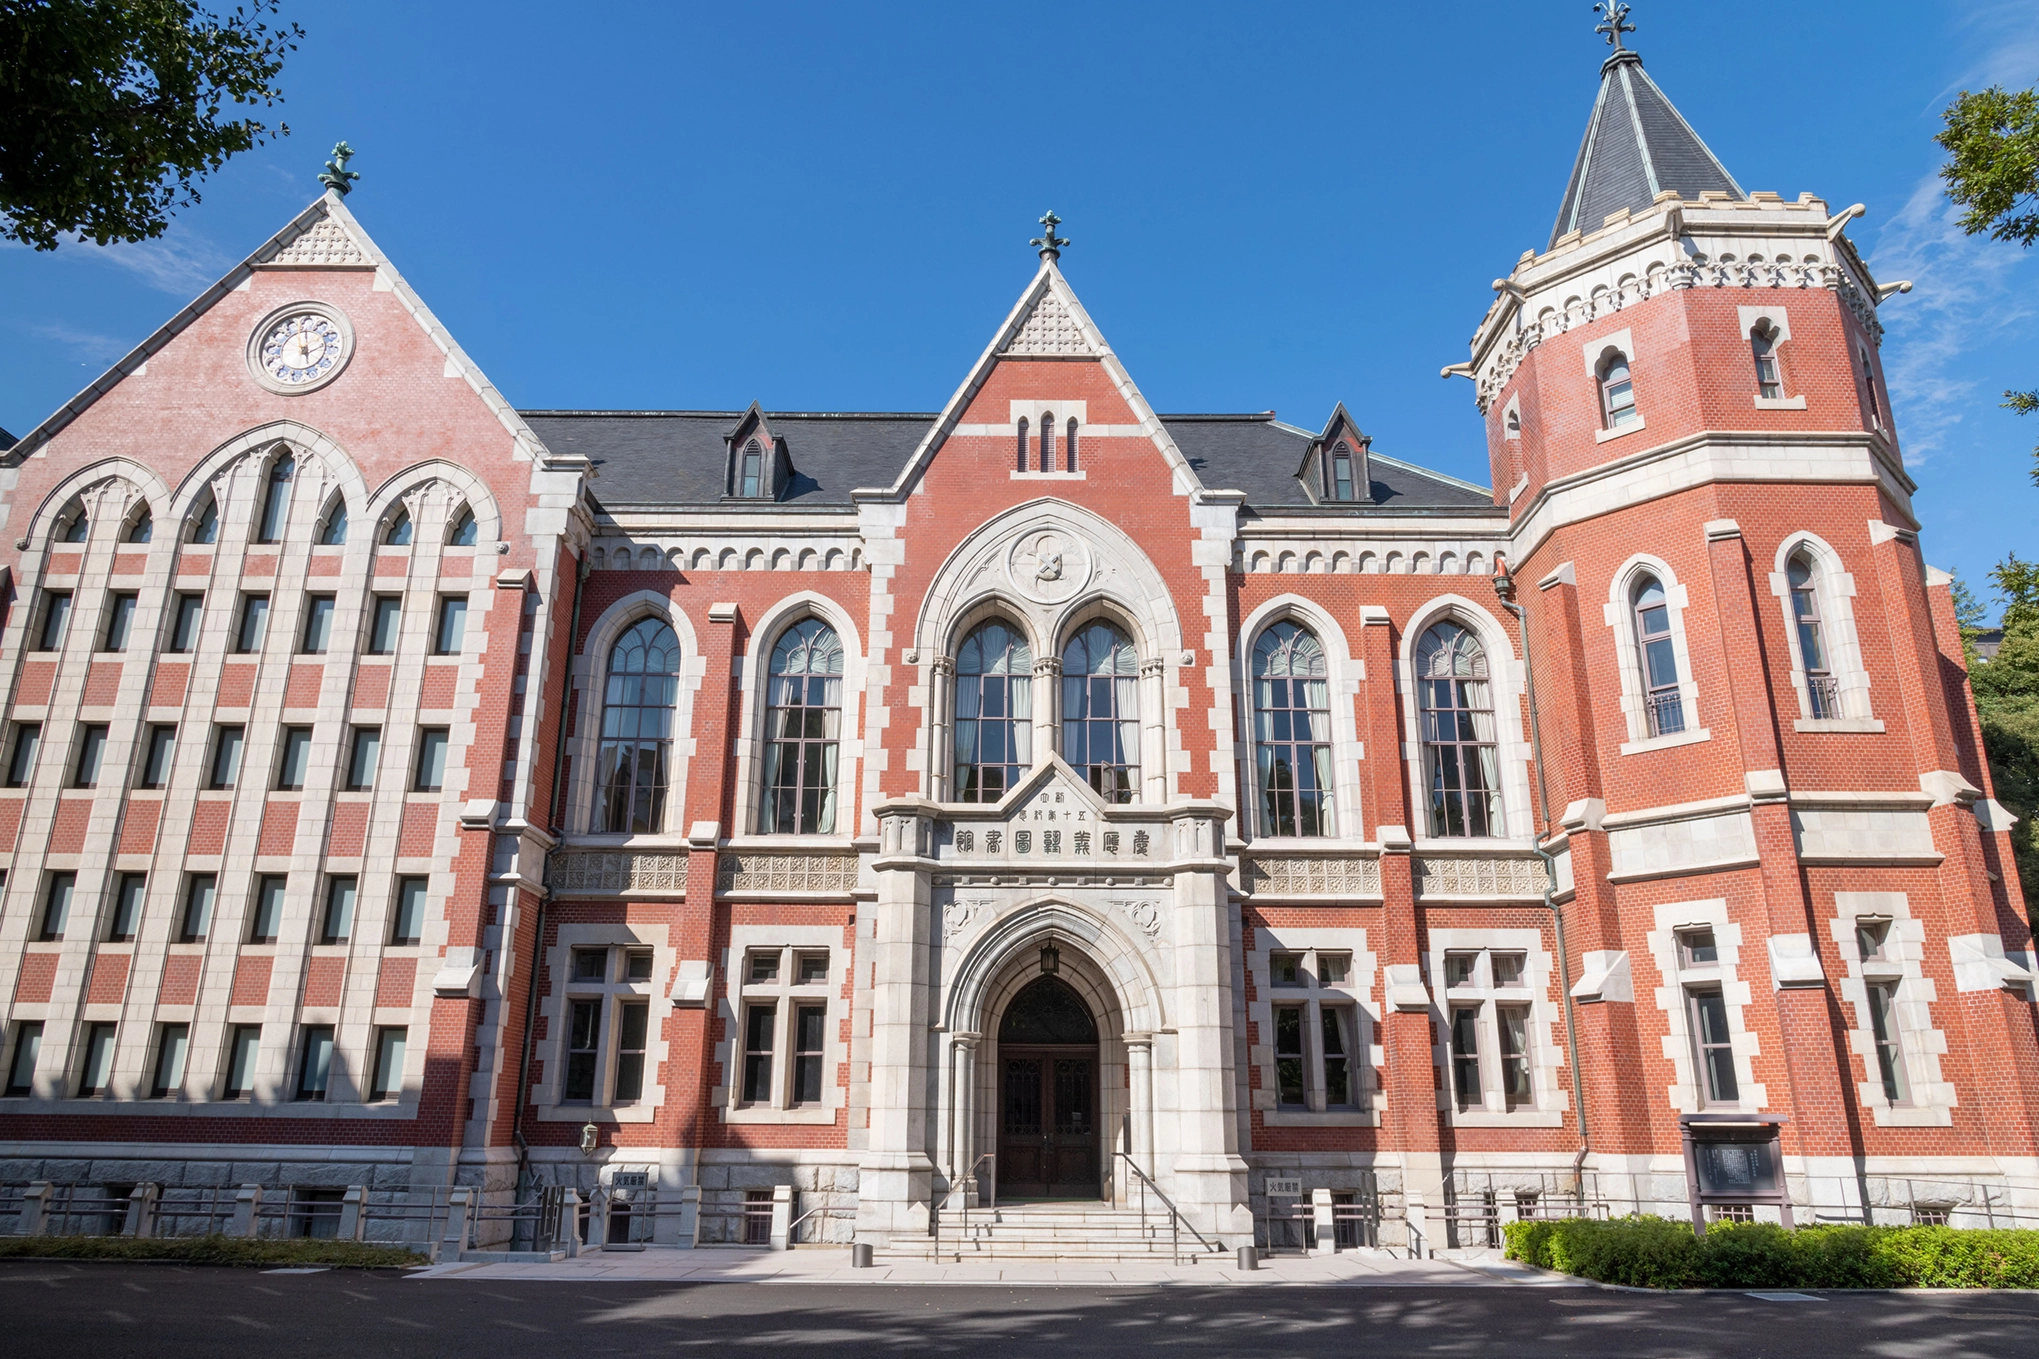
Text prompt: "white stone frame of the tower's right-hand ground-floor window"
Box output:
[[1827, 892, 1959, 1127]]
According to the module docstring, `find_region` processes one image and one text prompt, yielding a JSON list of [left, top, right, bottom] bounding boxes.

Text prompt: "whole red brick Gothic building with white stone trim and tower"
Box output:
[[0, 35, 2039, 1251]]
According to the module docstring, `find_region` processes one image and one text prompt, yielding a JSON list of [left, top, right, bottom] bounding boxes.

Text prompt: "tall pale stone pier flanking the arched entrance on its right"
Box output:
[[1150, 801, 1254, 1241]]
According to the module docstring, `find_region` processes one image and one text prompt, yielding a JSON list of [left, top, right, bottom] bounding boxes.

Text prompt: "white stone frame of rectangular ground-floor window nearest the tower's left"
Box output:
[[1423, 929, 1572, 1129]]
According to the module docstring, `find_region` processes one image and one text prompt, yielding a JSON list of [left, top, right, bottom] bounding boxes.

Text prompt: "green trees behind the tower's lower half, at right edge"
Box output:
[[1962, 552, 2039, 915]]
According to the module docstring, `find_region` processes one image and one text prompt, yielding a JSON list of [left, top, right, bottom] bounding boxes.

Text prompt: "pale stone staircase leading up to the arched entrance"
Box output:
[[881, 1200, 1217, 1265]]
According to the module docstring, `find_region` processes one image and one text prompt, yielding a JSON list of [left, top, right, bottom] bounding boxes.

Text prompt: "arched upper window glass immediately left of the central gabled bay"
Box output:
[[759, 617, 842, 835]]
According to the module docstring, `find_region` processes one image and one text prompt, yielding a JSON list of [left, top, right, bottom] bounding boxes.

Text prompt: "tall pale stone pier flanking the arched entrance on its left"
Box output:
[[856, 797, 938, 1245]]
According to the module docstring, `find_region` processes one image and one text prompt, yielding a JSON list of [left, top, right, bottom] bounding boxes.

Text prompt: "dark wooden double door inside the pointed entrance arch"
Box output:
[[997, 1043, 1103, 1198]]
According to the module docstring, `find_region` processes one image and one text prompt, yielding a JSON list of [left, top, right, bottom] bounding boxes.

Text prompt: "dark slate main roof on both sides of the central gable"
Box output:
[[518, 410, 1495, 515]]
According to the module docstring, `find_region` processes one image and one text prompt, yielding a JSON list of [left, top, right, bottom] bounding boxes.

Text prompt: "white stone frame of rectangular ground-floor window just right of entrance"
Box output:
[[1246, 921, 1387, 1127]]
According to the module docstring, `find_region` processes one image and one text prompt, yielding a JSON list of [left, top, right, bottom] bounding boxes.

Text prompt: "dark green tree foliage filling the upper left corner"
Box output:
[[0, 0, 304, 251]]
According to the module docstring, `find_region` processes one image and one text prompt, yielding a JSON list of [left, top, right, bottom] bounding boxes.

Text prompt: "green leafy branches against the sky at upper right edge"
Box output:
[[1933, 86, 2039, 483]]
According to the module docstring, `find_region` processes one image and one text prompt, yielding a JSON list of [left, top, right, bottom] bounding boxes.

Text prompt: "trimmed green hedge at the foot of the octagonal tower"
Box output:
[[1505, 1216, 2039, 1288]]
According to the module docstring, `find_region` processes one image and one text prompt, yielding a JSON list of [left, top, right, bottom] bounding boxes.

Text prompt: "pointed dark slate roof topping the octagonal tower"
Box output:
[[1550, 49, 1747, 244]]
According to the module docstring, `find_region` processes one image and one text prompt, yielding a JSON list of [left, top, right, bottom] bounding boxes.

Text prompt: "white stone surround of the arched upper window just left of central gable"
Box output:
[[729, 591, 867, 846]]
